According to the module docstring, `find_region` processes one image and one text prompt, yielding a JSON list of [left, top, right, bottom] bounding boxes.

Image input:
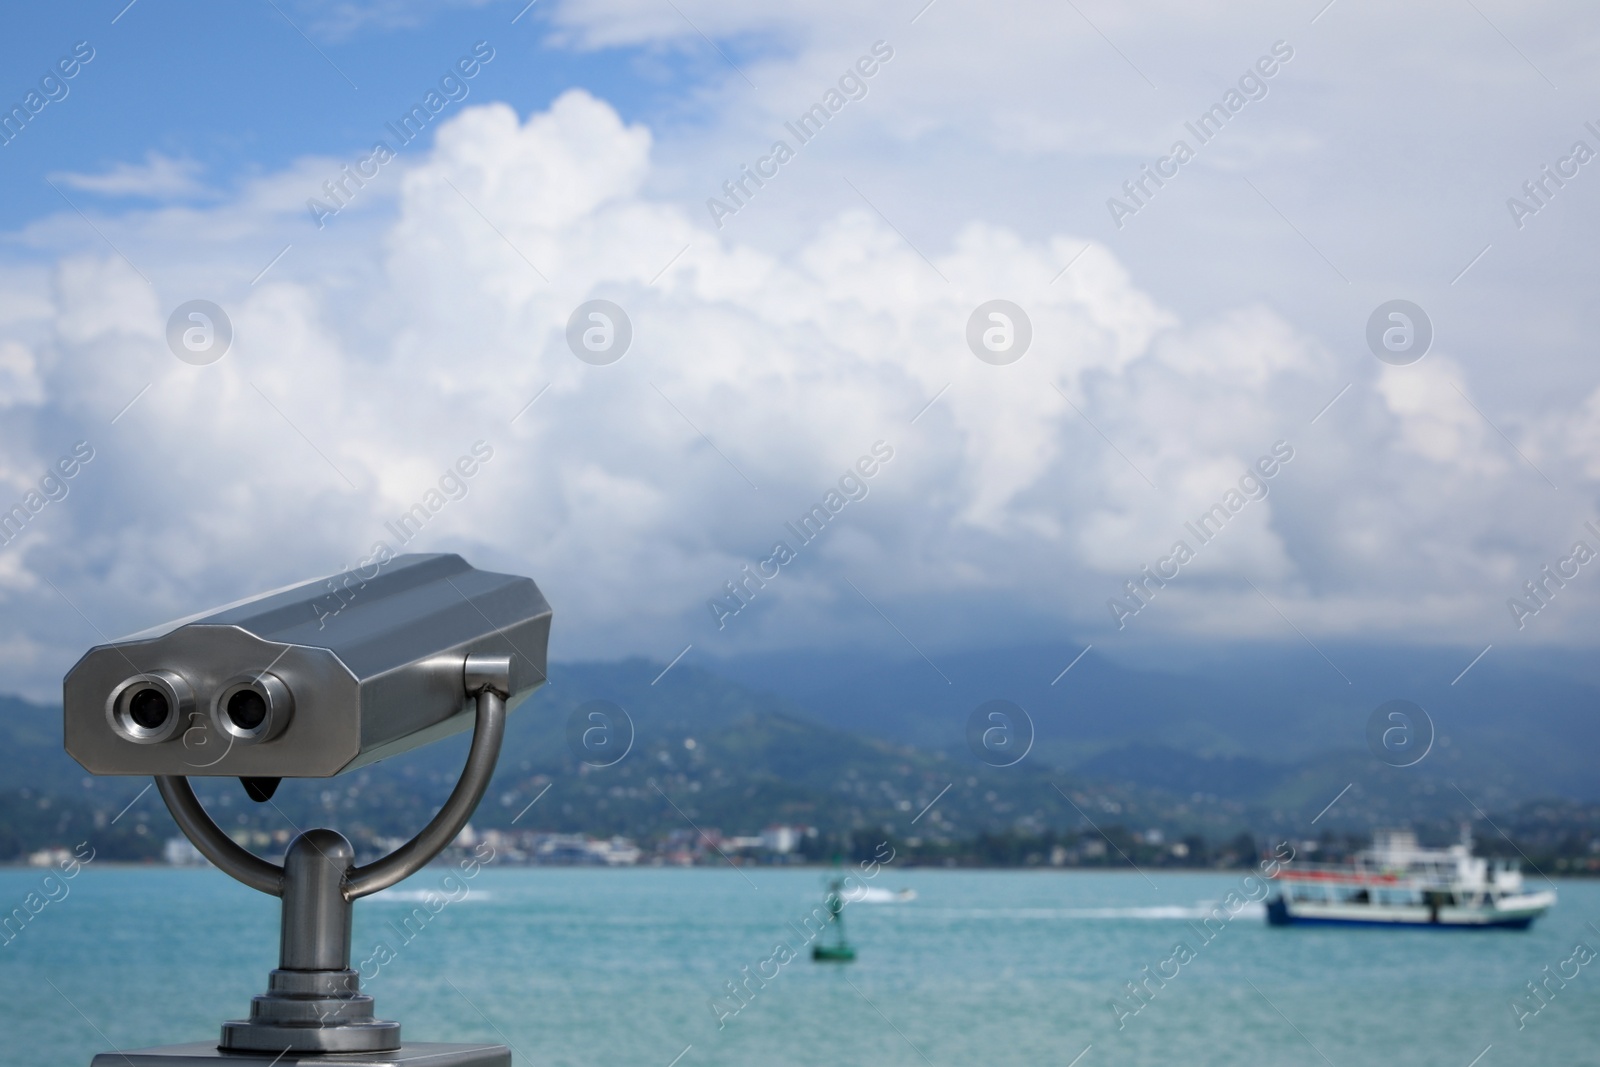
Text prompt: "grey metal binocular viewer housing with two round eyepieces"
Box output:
[[64, 555, 550, 777]]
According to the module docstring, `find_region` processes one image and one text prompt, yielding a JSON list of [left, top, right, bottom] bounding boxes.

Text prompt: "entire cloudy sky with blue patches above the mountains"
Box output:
[[0, 0, 1600, 694]]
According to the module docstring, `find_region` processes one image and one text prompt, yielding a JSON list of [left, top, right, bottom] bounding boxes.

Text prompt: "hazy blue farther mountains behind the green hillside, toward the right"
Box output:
[[715, 643, 1600, 803]]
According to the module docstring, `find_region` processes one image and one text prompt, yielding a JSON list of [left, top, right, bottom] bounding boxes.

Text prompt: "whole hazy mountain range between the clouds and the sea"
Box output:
[[0, 648, 1600, 857]]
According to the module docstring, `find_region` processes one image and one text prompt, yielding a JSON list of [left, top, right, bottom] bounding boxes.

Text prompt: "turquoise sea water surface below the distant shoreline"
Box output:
[[0, 864, 1600, 1067]]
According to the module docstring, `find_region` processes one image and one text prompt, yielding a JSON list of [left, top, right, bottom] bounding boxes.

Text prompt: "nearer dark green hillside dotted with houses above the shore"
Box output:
[[0, 659, 1600, 865]]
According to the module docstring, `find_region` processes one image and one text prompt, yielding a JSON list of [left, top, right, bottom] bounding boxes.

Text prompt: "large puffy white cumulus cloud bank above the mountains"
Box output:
[[0, 90, 1594, 693]]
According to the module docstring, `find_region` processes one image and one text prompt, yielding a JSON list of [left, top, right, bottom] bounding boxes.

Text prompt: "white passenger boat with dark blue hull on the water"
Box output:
[[1267, 829, 1555, 929]]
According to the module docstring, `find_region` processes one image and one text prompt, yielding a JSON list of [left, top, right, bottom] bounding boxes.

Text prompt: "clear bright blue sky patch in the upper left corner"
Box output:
[[0, 0, 713, 229]]
